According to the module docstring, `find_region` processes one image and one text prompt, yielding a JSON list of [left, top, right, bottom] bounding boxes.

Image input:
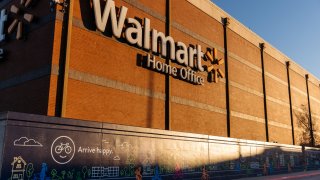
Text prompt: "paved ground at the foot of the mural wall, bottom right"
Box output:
[[242, 170, 320, 180]]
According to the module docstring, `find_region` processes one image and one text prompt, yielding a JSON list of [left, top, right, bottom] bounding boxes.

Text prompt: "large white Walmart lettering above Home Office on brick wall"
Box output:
[[93, 0, 204, 71]]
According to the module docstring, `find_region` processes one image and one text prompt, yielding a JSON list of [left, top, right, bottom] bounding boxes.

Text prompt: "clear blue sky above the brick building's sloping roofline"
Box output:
[[212, 0, 320, 79]]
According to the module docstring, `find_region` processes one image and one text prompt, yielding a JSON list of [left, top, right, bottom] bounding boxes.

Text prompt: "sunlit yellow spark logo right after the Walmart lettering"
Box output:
[[205, 48, 224, 83]]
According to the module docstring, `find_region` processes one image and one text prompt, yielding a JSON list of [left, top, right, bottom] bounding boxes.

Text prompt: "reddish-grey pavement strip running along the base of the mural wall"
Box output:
[[241, 170, 320, 180]]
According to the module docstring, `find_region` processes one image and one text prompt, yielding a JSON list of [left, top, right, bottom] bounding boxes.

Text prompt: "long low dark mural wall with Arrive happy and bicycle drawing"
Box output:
[[1, 113, 319, 180]]
